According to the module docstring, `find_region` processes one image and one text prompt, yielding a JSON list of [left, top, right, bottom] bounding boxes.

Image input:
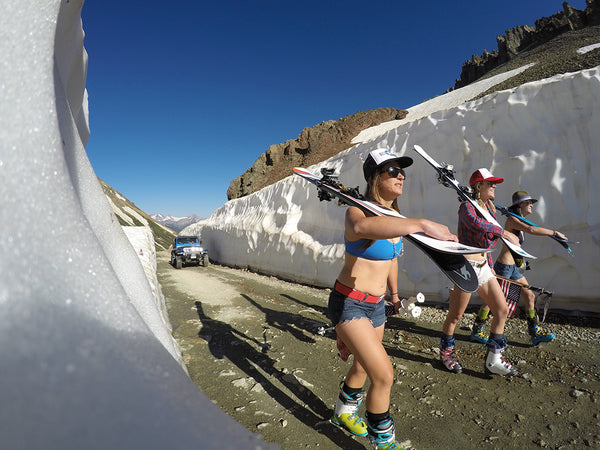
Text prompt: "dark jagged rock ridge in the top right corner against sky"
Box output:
[[450, 0, 600, 90]]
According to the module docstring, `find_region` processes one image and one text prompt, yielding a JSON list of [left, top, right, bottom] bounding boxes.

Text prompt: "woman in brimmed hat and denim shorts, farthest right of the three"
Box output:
[[471, 191, 567, 345]]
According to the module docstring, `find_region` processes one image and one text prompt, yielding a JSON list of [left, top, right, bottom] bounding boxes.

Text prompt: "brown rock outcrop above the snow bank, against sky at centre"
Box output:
[[227, 108, 408, 200]]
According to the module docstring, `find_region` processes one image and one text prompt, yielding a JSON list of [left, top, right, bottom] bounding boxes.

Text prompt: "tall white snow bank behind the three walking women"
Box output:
[[190, 67, 600, 312]]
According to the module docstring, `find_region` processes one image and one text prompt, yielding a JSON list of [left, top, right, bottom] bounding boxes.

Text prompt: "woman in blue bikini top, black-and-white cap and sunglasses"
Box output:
[[327, 148, 458, 450]]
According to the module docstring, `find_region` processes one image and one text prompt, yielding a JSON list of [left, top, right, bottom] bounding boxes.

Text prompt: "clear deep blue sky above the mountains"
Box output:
[[82, 0, 585, 217]]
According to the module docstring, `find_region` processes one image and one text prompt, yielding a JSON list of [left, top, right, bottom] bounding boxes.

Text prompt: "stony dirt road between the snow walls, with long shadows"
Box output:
[[158, 253, 600, 449]]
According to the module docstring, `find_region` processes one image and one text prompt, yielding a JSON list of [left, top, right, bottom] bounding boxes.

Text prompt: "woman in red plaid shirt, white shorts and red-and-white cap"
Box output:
[[440, 169, 518, 375]]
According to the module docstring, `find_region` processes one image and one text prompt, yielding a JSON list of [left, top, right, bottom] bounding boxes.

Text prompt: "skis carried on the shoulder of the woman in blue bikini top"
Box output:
[[293, 167, 489, 292]]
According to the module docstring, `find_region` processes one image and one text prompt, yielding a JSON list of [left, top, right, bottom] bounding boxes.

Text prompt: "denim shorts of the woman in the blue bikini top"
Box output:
[[327, 290, 386, 328]]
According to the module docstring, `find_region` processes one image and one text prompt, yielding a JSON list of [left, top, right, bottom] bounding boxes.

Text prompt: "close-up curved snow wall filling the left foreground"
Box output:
[[0, 0, 267, 449]]
